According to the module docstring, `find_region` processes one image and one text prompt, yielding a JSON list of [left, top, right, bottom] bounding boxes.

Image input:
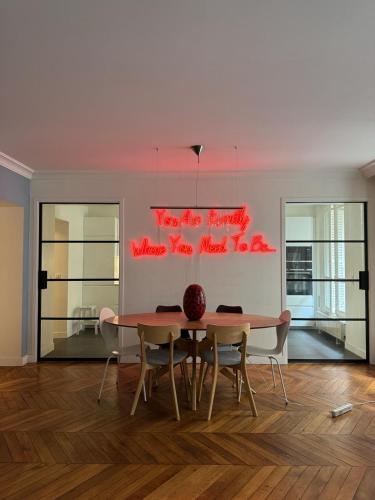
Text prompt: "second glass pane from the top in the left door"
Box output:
[[42, 243, 119, 279]]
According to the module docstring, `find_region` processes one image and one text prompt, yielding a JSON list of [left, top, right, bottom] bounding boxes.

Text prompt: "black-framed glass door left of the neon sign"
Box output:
[[38, 203, 119, 359]]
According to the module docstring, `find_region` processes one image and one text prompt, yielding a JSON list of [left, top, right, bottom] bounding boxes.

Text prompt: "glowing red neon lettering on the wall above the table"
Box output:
[[130, 206, 277, 258]]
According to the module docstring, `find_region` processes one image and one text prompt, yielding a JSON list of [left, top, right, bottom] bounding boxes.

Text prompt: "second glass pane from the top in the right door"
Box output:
[[286, 243, 365, 279]]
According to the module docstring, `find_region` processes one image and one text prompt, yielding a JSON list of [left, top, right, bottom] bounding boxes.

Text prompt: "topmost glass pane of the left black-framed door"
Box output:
[[42, 204, 119, 241]]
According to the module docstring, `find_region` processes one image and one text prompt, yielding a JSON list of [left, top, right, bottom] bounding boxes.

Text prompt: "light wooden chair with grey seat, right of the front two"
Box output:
[[198, 323, 258, 420]]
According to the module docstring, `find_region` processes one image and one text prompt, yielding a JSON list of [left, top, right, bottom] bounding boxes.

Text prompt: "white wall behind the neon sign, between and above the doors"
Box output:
[[31, 168, 374, 364]]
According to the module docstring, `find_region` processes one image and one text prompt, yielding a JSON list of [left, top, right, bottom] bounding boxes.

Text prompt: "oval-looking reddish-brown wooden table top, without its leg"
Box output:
[[105, 312, 281, 331]]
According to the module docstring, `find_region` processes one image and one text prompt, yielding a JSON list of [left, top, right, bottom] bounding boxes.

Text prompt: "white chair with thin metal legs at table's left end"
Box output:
[[98, 307, 147, 403]]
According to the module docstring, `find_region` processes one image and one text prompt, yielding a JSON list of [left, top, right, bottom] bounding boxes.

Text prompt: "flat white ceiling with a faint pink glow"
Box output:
[[0, 0, 375, 170]]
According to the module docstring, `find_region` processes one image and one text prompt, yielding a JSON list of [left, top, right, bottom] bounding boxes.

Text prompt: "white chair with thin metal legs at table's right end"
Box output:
[[245, 309, 291, 405]]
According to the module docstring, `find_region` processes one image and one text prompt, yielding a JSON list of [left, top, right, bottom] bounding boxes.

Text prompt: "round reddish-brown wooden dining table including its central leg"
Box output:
[[105, 312, 282, 410]]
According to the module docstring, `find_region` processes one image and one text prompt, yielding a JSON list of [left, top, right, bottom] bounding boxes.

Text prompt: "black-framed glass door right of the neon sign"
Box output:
[[285, 202, 368, 362]]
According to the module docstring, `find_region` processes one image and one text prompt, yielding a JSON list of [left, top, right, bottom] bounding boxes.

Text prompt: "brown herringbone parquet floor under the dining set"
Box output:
[[0, 362, 375, 499]]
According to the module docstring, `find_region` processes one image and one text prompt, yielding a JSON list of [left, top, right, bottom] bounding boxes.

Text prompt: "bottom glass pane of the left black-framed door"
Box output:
[[40, 319, 107, 358]]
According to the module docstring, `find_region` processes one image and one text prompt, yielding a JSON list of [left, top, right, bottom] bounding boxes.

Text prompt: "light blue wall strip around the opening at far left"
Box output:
[[0, 165, 30, 356]]
